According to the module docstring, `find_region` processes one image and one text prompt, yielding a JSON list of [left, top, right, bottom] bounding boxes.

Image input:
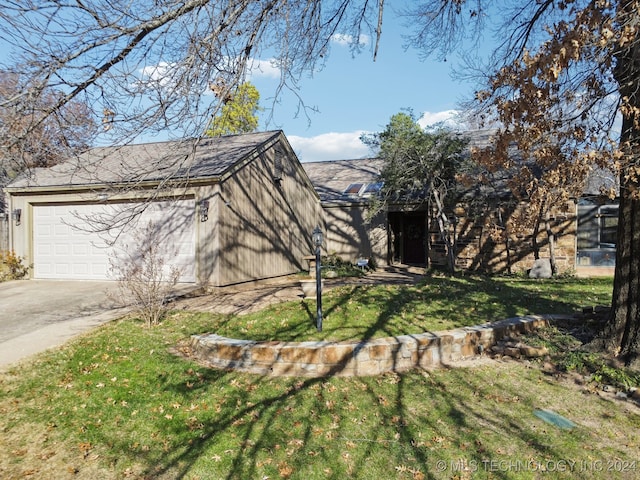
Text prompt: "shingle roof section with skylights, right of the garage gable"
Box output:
[[302, 158, 383, 203]]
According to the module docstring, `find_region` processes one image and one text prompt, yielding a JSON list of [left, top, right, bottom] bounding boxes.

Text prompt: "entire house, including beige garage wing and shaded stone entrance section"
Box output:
[[5, 127, 617, 286]]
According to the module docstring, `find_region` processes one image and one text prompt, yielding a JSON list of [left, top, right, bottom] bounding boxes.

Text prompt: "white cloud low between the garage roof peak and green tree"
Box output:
[[287, 130, 371, 162]]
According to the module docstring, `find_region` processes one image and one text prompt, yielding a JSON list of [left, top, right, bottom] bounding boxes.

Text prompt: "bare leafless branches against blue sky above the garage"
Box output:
[[0, 0, 382, 158]]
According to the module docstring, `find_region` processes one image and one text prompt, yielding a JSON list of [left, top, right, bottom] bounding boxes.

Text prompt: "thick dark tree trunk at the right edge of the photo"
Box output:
[[599, 0, 640, 367]]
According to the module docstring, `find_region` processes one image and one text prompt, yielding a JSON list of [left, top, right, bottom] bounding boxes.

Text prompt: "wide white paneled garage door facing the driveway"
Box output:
[[33, 200, 195, 282]]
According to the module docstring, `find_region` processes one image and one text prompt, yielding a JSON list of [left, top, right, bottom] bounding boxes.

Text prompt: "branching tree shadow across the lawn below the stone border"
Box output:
[[135, 352, 636, 479]]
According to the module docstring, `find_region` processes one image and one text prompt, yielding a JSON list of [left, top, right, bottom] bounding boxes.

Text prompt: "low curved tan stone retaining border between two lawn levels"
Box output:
[[191, 315, 575, 377]]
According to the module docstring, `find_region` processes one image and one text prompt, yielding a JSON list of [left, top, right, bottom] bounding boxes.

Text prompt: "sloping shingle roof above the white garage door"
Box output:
[[9, 130, 282, 189]]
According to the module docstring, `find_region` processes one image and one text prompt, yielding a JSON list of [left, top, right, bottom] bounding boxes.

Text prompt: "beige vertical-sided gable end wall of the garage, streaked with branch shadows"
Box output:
[[218, 137, 322, 285]]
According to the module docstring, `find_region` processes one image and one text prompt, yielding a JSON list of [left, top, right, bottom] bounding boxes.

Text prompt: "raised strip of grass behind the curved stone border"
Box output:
[[196, 276, 612, 341]]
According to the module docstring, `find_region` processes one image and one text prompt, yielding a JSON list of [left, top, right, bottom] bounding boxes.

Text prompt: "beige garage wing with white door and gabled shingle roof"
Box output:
[[5, 131, 321, 286]]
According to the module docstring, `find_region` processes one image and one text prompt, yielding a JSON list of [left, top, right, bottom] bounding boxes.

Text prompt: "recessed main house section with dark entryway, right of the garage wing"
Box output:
[[302, 154, 617, 276]]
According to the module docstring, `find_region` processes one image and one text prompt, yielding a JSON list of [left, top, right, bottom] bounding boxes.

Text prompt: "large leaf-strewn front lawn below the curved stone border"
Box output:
[[0, 281, 640, 480]]
